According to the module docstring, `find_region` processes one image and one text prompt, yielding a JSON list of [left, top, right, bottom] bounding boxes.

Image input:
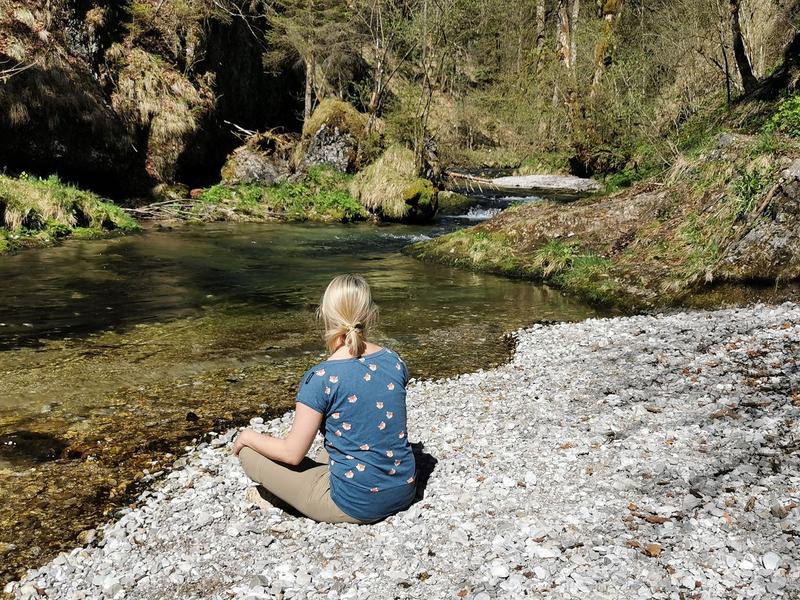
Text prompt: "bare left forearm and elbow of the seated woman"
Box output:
[[233, 402, 322, 465]]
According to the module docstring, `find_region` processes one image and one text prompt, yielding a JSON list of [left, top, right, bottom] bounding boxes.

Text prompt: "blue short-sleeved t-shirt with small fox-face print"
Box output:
[[297, 348, 416, 521]]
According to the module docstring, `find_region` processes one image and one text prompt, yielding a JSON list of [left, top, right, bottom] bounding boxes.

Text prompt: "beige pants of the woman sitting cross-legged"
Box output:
[[239, 447, 362, 524]]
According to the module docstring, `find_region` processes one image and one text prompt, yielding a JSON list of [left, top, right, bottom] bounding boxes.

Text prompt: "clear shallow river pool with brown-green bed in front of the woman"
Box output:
[[0, 219, 598, 581]]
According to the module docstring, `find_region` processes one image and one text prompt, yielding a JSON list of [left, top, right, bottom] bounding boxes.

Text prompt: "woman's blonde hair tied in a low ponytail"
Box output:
[[317, 275, 378, 356]]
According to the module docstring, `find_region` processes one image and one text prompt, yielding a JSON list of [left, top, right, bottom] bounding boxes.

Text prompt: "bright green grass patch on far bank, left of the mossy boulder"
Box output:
[[196, 167, 369, 222]]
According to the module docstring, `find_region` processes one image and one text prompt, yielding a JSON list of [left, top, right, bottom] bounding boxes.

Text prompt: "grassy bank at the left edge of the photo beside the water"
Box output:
[[0, 173, 139, 252]]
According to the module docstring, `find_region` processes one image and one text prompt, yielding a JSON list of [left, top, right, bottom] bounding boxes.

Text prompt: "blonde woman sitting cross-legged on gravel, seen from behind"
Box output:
[[233, 275, 416, 523]]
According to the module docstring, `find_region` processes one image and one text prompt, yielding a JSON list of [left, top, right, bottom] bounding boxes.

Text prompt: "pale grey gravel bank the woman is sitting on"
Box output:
[[6, 304, 800, 600]]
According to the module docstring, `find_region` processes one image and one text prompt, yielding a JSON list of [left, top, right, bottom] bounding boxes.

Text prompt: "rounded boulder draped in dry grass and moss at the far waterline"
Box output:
[[350, 145, 438, 222]]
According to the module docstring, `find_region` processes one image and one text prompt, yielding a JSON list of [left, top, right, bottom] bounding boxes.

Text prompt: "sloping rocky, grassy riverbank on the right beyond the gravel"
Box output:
[[407, 134, 800, 308]]
